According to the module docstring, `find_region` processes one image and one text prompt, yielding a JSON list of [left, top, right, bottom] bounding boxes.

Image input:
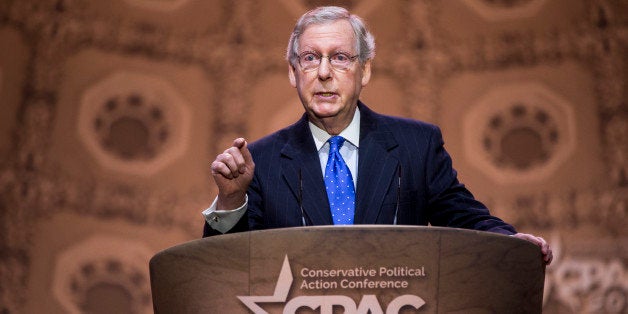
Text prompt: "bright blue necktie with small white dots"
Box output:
[[325, 136, 355, 225]]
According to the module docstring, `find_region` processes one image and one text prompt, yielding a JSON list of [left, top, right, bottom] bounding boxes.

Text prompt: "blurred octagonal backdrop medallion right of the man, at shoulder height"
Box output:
[[464, 83, 576, 183]]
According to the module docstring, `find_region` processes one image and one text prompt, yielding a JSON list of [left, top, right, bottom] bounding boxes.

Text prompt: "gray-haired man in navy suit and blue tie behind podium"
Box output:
[[203, 7, 552, 263]]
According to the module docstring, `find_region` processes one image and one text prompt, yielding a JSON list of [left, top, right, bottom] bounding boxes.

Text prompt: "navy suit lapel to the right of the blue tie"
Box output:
[[355, 103, 399, 224]]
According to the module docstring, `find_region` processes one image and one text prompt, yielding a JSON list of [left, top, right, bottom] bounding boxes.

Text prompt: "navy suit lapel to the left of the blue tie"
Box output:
[[281, 115, 333, 225]]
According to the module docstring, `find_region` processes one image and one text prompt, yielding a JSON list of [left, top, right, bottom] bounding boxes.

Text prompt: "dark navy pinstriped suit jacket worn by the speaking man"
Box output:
[[204, 103, 516, 236]]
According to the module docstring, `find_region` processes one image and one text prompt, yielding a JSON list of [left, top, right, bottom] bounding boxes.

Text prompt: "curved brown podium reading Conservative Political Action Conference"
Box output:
[[149, 225, 545, 314]]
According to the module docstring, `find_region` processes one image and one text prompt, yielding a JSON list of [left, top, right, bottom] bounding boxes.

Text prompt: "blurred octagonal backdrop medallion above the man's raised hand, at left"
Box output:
[[79, 72, 190, 175]]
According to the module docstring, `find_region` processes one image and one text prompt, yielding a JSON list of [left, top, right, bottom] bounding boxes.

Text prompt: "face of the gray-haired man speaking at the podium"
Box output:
[[289, 20, 371, 134]]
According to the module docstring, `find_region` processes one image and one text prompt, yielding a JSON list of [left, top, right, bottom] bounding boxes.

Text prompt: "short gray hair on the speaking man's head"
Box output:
[[286, 6, 375, 67]]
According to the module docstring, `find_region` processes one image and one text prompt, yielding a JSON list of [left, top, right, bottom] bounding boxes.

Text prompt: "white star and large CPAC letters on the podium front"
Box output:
[[238, 256, 425, 314]]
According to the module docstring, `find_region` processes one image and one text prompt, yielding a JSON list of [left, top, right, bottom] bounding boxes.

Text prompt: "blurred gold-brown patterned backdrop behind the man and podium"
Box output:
[[0, 0, 628, 314]]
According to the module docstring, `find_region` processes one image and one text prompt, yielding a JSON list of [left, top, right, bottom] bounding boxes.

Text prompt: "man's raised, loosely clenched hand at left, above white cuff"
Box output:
[[211, 138, 255, 210]]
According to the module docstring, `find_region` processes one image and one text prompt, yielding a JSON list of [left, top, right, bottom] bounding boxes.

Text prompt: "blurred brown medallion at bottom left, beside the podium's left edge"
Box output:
[[52, 236, 152, 314]]
